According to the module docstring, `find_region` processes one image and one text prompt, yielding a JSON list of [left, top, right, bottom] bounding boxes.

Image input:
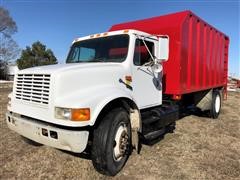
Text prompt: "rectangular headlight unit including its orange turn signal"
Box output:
[[55, 107, 90, 121]]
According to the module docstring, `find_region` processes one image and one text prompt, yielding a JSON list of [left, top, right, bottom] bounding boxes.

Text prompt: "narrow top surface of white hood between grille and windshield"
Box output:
[[18, 62, 120, 74]]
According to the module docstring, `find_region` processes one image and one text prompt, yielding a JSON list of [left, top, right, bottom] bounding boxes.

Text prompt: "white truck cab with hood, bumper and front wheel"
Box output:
[[6, 29, 169, 175]]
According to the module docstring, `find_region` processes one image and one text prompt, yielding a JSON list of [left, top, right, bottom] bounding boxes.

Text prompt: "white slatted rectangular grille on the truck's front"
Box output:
[[15, 74, 50, 104]]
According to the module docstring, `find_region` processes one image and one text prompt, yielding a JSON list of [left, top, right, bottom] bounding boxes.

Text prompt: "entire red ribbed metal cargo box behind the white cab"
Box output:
[[110, 11, 229, 95]]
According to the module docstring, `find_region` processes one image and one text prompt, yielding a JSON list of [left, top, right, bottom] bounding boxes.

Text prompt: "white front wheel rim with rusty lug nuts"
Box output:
[[113, 125, 128, 161]]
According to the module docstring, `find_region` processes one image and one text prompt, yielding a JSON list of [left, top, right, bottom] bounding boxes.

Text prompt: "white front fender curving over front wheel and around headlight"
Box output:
[[56, 86, 134, 126]]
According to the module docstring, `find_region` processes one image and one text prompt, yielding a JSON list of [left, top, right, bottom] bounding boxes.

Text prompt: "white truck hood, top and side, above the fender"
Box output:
[[18, 62, 128, 99]]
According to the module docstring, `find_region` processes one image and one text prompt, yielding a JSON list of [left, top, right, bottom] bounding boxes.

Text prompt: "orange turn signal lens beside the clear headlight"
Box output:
[[71, 108, 90, 121]]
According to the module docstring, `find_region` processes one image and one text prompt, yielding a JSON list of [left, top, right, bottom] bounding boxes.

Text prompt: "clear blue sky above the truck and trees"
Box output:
[[0, 0, 240, 77]]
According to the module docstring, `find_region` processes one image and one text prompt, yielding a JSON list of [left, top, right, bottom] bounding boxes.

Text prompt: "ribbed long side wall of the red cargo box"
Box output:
[[180, 13, 229, 94]]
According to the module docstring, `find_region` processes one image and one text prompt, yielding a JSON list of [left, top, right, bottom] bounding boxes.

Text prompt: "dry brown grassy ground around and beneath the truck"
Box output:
[[0, 86, 240, 180]]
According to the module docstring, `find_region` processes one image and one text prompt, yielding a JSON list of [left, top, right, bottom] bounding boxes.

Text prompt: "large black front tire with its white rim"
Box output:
[[91, 108, 131, 176]]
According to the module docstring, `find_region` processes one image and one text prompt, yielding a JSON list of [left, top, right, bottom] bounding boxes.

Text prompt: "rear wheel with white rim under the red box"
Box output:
[[210, 90, 222, 119]]
